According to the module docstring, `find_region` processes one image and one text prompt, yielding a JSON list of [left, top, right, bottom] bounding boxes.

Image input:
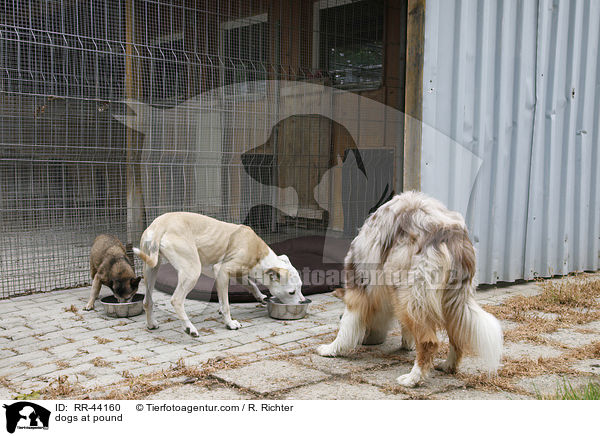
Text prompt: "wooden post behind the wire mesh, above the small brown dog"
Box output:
[[125, 0, 144, 261]]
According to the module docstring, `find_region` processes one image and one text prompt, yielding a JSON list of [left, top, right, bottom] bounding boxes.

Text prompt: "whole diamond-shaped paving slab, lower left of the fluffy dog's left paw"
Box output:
[[213, 360, 329, 394]]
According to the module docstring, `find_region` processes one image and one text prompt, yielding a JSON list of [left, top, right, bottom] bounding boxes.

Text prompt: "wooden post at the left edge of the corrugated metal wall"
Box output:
[[403, 0, 425, 191]]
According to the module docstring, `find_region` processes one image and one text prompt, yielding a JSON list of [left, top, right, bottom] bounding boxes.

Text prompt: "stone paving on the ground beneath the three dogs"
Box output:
[[0, 283, 600, 400]]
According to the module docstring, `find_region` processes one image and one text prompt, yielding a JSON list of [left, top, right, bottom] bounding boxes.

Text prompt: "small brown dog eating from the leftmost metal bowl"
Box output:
[[85, 235, 142, 310]]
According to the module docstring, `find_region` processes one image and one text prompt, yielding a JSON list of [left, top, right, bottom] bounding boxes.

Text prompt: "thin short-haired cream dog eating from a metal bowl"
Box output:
[[133, 212, 305, 336]]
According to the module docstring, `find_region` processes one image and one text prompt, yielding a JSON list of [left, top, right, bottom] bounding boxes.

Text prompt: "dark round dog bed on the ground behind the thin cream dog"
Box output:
[[155, 236, 351, 303]]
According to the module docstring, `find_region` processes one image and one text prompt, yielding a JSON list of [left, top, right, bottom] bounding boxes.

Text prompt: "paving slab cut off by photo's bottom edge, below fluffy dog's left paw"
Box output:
[[281, 380, 409, 400]]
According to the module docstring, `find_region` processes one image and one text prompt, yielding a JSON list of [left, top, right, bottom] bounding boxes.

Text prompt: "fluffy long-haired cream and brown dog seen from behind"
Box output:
[[317, 192, 503, 387]]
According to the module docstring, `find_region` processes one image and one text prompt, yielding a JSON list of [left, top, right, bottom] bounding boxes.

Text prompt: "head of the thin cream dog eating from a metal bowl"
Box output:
[[263, 254, 305, 304]]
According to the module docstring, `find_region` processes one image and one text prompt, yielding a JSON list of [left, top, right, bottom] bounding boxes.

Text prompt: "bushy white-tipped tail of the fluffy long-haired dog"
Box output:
[[443, 283, 503, 372]]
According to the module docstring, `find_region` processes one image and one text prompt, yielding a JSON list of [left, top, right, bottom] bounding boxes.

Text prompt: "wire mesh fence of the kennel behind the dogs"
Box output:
[[0, 0, 405, 297]]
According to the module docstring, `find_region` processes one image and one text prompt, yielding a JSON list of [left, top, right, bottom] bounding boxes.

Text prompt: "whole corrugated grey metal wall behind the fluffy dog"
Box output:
[[421, 0, 600, 283]]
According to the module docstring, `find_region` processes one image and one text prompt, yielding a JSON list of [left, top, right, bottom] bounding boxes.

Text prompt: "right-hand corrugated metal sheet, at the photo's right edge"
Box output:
[[525, 1, 600, 279]]
